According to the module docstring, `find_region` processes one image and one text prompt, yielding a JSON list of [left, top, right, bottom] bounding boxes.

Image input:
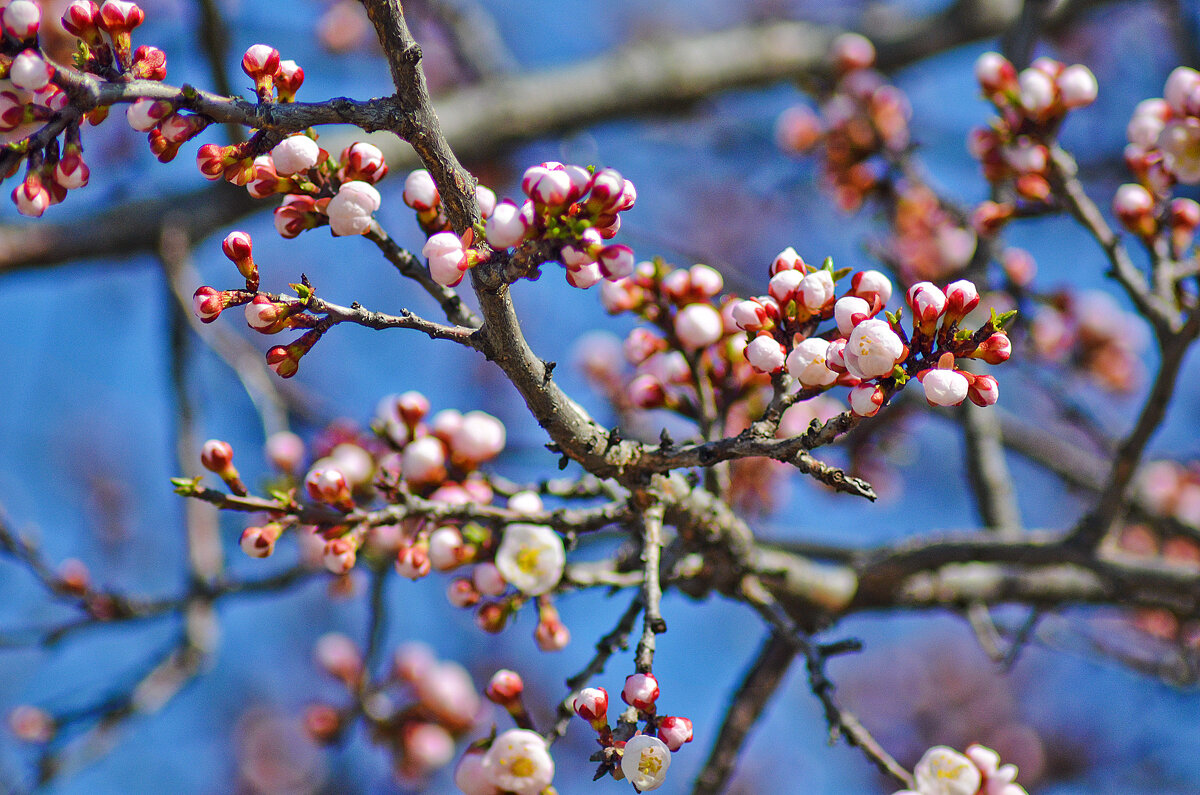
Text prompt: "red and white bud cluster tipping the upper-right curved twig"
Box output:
[[968, 53, 1097, 216]]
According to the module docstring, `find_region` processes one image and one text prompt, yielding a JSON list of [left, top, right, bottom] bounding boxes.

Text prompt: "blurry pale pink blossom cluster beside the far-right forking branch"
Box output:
[[1028, 291, 1150, 393]]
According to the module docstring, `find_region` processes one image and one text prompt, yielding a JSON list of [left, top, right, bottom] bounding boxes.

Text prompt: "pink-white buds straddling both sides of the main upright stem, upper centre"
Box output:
[[415, 162, 637, 289]]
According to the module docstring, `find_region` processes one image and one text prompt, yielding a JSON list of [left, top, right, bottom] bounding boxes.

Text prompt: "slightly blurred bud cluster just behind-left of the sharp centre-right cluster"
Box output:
[[600, 259, 764, 418]]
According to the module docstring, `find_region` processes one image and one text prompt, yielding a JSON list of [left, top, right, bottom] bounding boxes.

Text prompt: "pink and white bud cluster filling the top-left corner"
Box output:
[[0, 0, 164, 216]]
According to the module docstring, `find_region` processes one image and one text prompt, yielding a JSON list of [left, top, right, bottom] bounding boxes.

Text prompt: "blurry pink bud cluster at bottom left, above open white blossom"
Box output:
[[305, 633, 486, 785]]
